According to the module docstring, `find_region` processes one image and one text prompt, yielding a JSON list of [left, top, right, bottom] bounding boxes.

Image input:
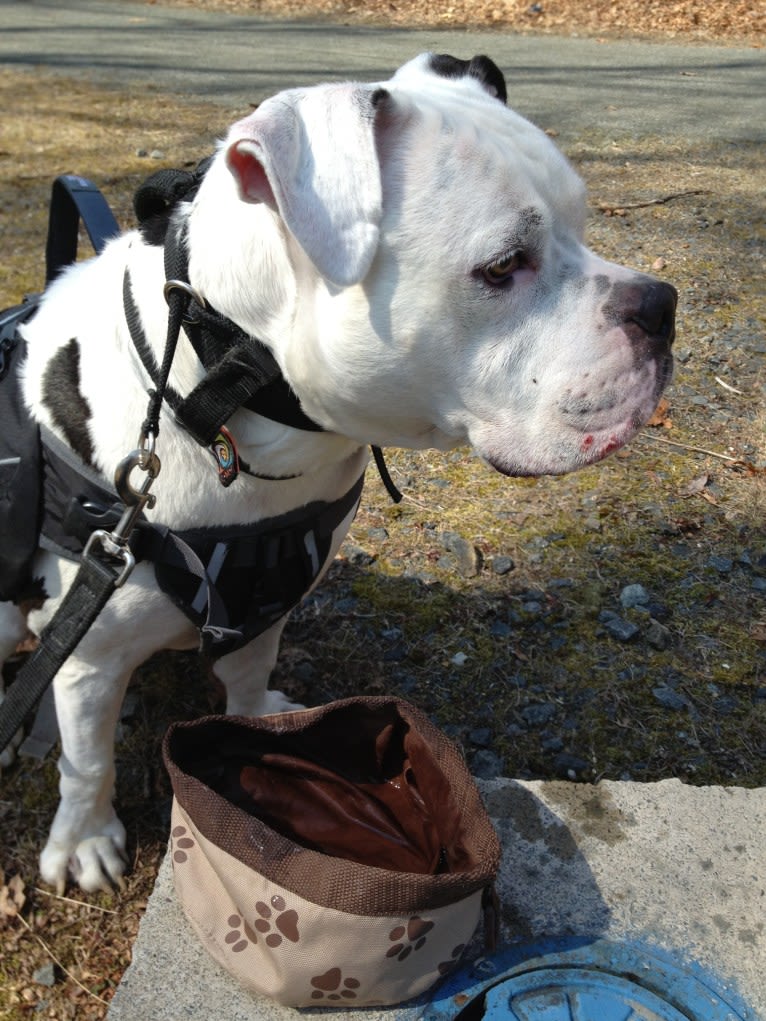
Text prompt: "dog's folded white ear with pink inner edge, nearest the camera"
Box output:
[[225, 85, 387, 287]]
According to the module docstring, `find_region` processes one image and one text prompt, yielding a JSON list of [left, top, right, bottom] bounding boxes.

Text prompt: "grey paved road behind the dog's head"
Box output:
[[0, 0, 766, 142]]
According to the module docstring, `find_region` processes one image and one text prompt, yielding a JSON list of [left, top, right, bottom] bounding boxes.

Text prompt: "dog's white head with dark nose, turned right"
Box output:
[[193, 54, 676, 475]]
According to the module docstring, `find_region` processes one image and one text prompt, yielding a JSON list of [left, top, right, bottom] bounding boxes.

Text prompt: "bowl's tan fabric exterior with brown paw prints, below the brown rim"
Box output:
[[172, 803, 481, 1007]]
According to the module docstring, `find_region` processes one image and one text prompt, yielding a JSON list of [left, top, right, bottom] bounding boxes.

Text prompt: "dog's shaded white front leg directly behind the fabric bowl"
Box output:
[[213, 619, 302, 716]]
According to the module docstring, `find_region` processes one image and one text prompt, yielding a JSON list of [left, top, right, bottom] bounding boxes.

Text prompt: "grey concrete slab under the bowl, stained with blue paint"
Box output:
[[108, 779, 766, 1021]]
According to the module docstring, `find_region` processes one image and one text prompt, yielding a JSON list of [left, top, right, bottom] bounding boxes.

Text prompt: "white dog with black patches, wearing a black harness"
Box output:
[[0, 54, 676, 890]]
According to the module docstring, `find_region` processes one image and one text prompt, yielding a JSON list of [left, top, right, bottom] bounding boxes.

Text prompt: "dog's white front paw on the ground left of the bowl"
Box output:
[[40, 816, 127, 893]]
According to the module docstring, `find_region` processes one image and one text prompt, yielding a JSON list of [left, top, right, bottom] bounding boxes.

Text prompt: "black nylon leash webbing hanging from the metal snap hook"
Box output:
[[0, 556, 117, 751]]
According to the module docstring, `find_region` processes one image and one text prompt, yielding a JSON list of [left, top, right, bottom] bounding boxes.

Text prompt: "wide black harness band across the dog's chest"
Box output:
[[42, 427, 364, 657]]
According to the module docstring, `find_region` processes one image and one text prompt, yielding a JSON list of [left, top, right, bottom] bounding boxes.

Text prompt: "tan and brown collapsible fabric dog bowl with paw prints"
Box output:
[[163, 697, 500, 1007]]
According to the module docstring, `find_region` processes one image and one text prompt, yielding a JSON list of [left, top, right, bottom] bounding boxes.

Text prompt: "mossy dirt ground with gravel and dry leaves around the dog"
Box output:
[[0, 0, 766, 1021]]
